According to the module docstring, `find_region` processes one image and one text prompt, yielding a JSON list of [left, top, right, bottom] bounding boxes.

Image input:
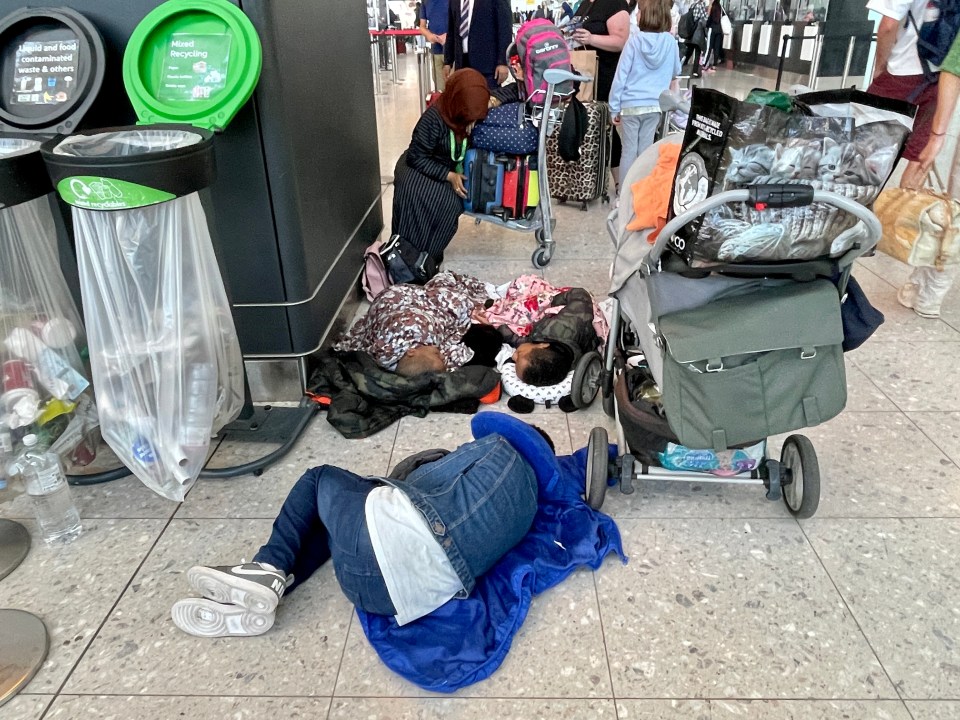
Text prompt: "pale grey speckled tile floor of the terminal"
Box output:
[[0, 52, 960, 720]]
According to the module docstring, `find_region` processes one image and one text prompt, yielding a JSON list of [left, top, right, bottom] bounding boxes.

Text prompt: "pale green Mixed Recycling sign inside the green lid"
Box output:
[[157, 32, 232, 103]]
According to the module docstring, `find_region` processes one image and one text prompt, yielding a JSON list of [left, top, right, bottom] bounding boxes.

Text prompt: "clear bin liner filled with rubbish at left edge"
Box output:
[[0, 138, 97, 465]]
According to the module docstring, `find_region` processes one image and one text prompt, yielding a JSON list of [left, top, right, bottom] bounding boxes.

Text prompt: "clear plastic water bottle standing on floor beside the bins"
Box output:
[[20, 435, 83, 545]]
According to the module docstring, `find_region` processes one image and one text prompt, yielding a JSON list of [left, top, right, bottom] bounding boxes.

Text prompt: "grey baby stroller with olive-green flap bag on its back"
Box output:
[[586, 135, 881, 518]]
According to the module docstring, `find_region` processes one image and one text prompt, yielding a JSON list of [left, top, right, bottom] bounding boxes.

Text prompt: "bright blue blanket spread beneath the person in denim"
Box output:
[[357, 412, 626, 692]]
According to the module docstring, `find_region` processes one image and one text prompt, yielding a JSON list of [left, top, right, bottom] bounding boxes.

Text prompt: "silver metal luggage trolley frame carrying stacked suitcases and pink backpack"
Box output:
[[464, 68, 593, 269]]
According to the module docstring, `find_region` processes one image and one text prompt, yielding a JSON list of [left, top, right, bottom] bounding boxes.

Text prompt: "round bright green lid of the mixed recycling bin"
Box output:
[[123, 0, 263, 130]]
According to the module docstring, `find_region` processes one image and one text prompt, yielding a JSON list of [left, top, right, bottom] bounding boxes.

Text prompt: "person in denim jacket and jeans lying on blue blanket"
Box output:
[[171, 413, 553, 637]]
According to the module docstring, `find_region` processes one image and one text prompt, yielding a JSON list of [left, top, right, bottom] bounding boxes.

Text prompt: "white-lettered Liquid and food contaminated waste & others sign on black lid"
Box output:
[[10, 37, 80, 105]]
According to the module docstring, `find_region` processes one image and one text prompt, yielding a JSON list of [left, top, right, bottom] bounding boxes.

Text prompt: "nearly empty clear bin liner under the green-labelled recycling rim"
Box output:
[[64, 131, 243, 501]]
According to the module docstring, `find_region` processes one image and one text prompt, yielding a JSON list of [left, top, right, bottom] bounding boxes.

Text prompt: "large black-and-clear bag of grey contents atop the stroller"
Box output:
[[671, 88, 915, 266]]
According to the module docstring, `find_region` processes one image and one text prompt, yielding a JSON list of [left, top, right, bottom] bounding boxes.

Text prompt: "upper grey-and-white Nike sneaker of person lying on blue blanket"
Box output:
[[187, 563, 292, 615]]
